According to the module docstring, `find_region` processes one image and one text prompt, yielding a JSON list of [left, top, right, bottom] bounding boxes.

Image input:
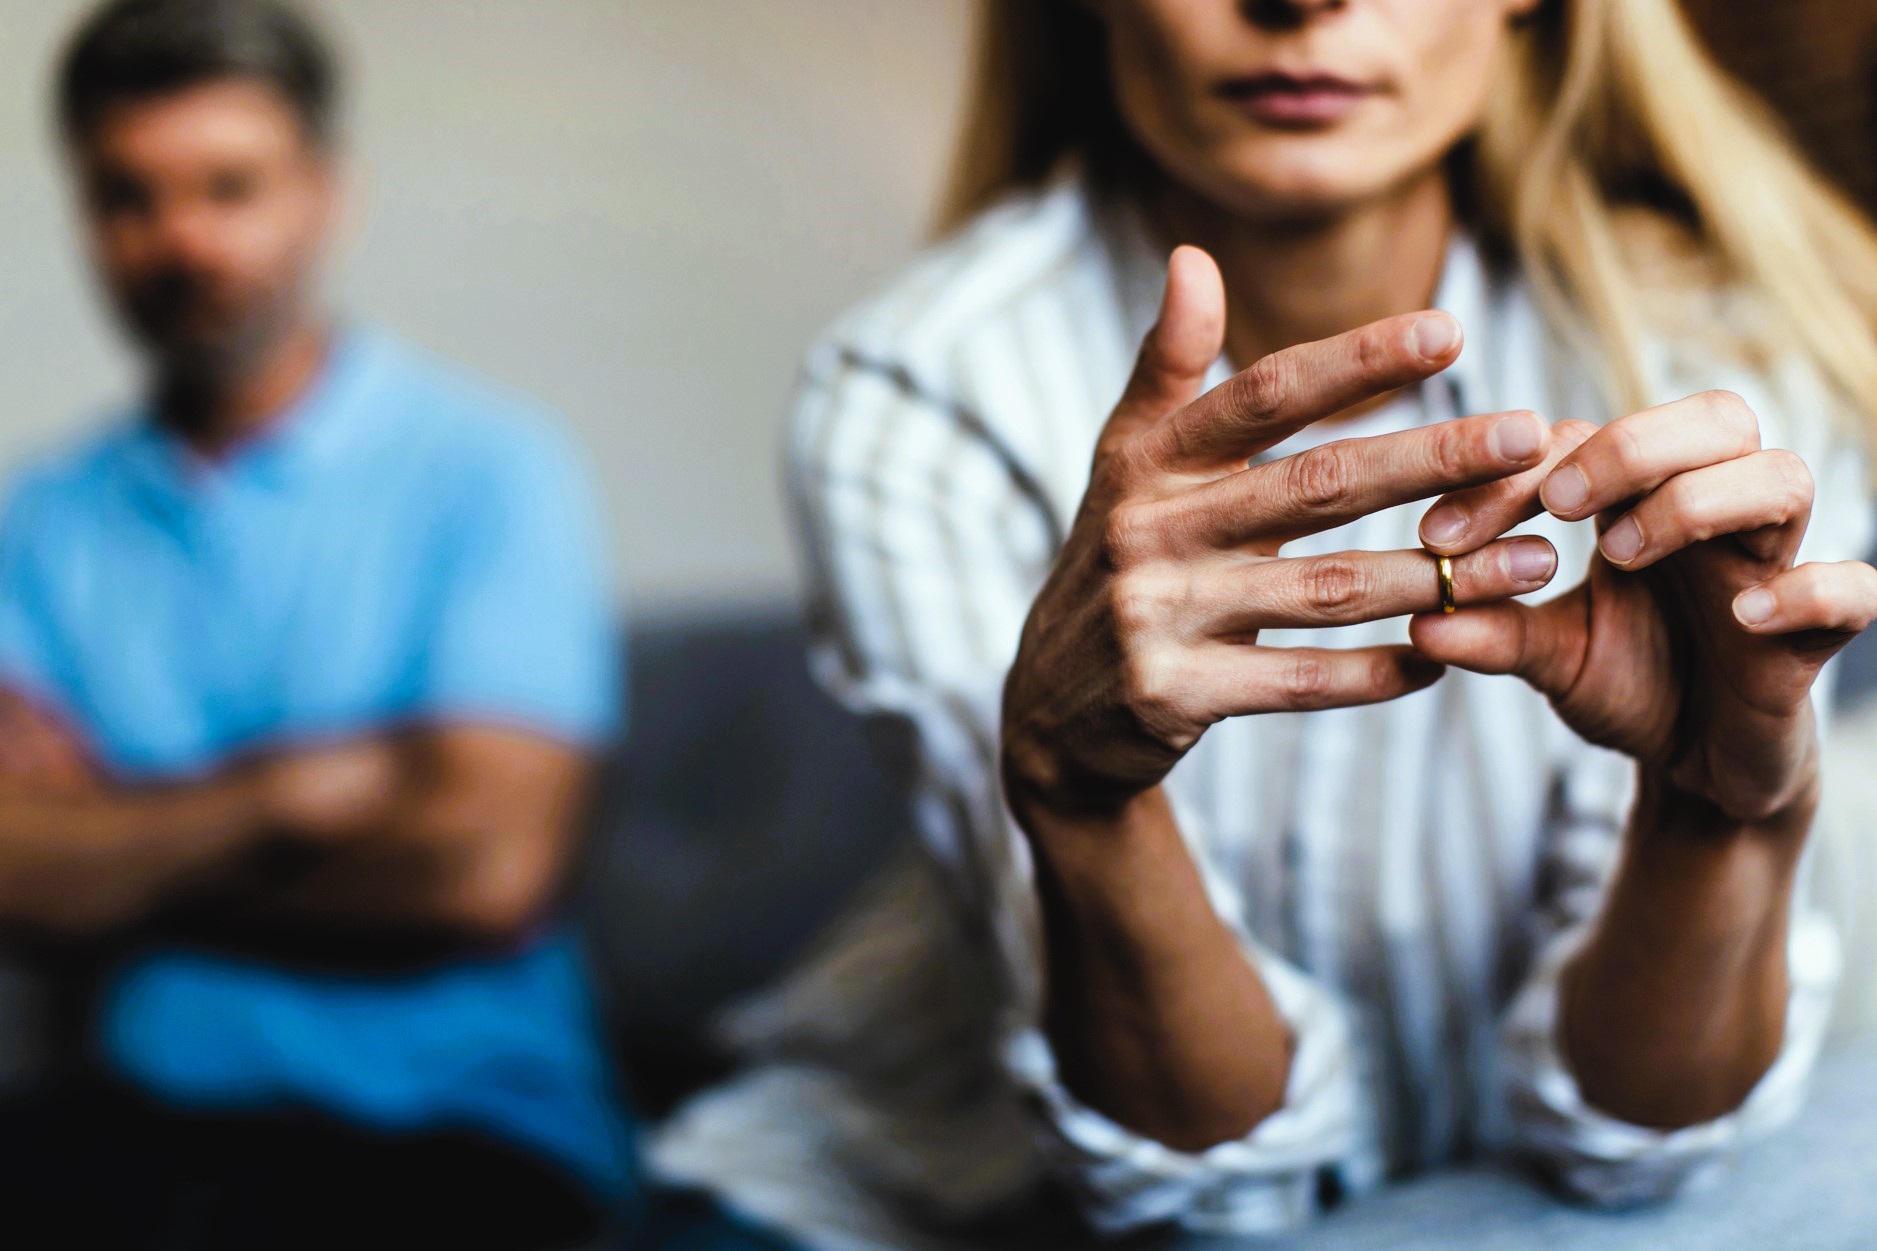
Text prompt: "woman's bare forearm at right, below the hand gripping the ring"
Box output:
[[1560, 780, 1815, 1129]]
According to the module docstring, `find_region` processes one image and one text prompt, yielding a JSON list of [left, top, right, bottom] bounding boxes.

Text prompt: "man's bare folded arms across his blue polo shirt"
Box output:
[[0, 725, 591, 945]]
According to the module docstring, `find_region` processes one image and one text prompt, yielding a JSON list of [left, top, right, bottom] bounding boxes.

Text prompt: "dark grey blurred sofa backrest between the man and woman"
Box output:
[[582, 609, 908, 1110]]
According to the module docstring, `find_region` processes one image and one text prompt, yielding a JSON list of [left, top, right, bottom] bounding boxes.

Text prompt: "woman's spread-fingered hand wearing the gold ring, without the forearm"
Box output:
[[1002, 248, 1558, 826]]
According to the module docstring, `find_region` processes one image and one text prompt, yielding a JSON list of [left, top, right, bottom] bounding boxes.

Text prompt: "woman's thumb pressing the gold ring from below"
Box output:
[[1408, 588, 1590, 695]]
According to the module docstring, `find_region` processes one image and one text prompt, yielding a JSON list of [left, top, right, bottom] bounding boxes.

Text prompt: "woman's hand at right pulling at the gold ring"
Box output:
[[1412, 391, 1877, 823]]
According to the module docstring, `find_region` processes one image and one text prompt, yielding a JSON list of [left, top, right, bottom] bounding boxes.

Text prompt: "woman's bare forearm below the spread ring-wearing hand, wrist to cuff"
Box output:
[[1021, 789, 1291, 1151]]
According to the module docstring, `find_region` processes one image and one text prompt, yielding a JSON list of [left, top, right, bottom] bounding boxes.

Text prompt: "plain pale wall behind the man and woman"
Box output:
[[0, 0, 970, 614]]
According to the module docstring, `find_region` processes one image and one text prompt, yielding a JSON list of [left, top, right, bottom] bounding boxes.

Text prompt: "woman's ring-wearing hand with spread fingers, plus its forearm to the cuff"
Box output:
[[1002, 248, 1556, 1151]]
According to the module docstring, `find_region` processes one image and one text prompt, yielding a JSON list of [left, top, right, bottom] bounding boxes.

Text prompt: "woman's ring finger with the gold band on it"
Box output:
[[1214, 537, 1558, 637]]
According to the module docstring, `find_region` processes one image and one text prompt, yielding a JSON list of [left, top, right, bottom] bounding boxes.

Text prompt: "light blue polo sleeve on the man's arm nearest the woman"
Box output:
[[417, 426, 625, 748]]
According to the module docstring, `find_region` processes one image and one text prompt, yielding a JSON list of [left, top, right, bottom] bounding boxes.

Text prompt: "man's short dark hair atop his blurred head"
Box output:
[[58, 0, 338, 147]]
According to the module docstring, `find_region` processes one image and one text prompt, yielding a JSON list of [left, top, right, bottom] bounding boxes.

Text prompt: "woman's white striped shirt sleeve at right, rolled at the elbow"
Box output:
[[1505, 360, 1871, 1204]]
